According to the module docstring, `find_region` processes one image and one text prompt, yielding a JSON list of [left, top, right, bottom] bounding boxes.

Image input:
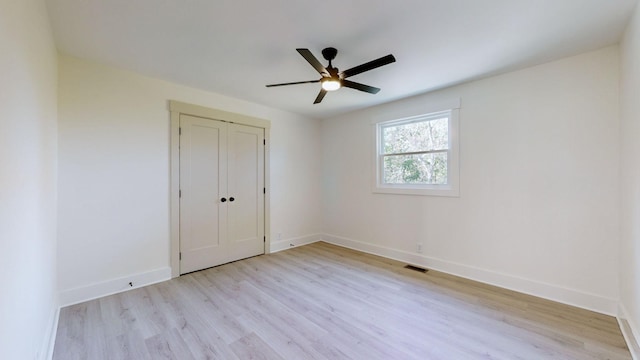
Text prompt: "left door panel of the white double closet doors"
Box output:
[[180, 115, 229, 274]]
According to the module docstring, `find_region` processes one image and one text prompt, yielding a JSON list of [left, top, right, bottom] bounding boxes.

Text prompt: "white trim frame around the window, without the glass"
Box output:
[[373, 103, 460, 197]]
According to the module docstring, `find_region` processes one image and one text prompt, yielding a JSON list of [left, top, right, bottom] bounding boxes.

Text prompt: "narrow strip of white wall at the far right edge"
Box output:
[[620, 0, 640, 356]]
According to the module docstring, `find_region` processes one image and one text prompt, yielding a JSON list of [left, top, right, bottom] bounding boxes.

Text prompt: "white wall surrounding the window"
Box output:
[[322, 47, 624, 314]]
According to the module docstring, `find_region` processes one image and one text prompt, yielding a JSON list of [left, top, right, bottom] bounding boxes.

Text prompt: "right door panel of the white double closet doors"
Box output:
[[227, 124, 265, 261]]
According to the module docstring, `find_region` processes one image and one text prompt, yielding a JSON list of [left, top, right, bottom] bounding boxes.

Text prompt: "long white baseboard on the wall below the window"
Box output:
[[322, 234, 618, 316]]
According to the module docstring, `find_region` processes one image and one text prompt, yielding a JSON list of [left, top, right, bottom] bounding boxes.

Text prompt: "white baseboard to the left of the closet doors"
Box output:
[[60, 267, 171, 307]]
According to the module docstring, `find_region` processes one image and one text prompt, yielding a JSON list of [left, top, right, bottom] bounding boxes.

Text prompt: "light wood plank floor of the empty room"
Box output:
[[54, 243, 631, 360]]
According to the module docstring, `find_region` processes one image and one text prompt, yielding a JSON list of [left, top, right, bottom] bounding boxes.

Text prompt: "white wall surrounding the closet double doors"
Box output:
[[58, 56, 321, 304]]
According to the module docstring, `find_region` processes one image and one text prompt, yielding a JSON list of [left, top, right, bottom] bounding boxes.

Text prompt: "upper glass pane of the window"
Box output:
[[382, 117, 449, 154]]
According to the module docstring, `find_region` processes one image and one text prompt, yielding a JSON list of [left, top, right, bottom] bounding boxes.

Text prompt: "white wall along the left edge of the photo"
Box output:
[[0, 0, 57, 359]]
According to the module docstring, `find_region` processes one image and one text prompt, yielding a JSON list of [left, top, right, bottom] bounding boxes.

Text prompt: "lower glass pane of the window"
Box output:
[[383, 152, 447, 185]]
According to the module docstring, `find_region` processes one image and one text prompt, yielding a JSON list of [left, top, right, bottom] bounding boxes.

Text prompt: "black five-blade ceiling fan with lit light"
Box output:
[[267, 47, 396, 104]]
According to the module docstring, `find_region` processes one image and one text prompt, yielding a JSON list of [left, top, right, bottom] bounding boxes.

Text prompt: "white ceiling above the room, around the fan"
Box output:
[[47, 0, 637, 118]]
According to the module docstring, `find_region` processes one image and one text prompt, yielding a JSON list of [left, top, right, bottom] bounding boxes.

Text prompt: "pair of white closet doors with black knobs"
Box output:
[[180, 115, 264, 274]]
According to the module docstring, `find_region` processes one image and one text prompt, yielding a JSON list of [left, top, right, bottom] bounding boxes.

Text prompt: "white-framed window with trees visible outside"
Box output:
[[374, 109, 458, 196]]
